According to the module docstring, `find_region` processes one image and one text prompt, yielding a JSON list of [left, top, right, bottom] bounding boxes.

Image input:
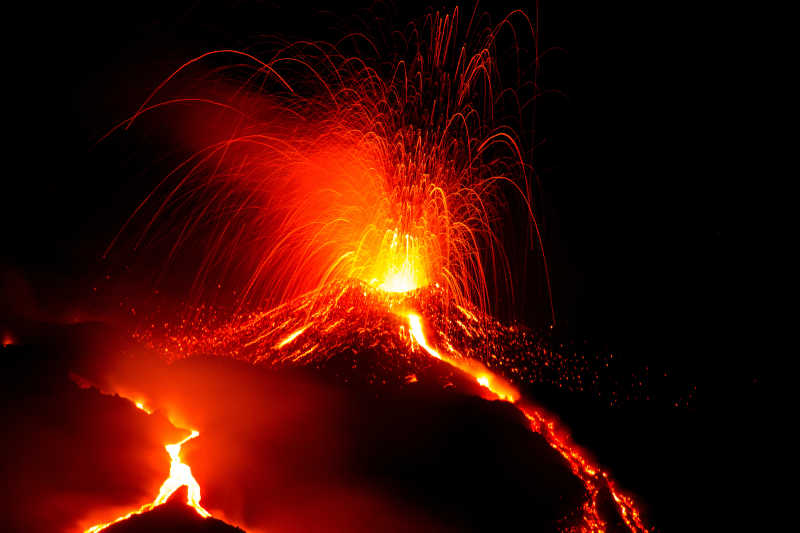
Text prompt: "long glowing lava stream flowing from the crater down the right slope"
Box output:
[[406, 313, 647, 532]]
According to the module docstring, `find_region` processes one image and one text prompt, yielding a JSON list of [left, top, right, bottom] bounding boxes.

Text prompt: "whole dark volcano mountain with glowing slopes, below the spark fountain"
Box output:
[[1, 281, 644, 531]]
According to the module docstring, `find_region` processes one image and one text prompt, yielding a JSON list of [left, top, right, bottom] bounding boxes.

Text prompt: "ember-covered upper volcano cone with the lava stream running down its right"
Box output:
[[139, 281, 646, 531]]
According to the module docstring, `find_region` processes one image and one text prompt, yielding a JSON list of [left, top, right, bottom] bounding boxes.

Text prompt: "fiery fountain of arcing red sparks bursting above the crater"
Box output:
[[106, 9, 552, 320]]
